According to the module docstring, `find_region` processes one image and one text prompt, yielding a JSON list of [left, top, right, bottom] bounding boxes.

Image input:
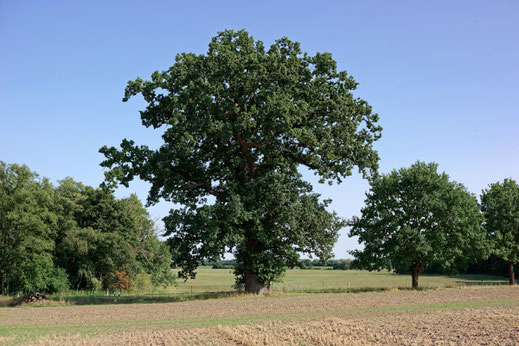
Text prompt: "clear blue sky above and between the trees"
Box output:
[[0, 0, 519, 258]]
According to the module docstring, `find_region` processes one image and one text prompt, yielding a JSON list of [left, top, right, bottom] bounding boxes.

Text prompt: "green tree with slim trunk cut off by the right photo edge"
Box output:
[[481, 179, 519, 285]]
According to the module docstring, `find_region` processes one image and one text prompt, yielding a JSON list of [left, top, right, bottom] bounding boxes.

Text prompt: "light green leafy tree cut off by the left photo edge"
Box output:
[[0, 161, 66, 294]]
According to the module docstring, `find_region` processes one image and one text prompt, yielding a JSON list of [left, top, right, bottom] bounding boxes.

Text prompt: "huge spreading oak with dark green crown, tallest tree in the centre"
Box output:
[[100, 30, 381, 293]]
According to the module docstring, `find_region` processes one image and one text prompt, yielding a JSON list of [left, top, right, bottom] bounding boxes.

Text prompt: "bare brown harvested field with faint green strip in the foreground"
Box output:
[[0, 287, 519, 345]]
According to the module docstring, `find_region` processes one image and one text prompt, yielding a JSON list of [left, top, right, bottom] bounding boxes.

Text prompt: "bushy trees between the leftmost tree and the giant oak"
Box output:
[[57, 179, 174, 289]]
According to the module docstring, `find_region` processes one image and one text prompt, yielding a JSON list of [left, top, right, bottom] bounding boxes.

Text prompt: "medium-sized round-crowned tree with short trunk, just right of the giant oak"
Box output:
[[349, 161, 490, 288]]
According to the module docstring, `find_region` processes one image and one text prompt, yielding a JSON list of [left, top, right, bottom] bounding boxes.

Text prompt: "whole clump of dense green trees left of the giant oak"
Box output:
[[0, 161, 174, 295]]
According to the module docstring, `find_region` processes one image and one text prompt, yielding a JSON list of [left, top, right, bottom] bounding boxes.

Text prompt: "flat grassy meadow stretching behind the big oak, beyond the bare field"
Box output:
[[0, 266, 508, 306]]
